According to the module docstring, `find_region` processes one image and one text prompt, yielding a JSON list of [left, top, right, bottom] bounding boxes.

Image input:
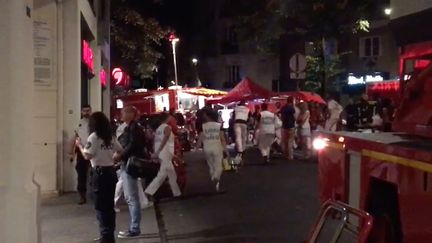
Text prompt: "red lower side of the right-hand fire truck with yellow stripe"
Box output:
[[319, 133, 432, 243]]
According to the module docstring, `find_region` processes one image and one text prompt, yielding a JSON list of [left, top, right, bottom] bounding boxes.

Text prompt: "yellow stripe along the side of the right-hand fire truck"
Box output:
[[362, 149, 432, 173]]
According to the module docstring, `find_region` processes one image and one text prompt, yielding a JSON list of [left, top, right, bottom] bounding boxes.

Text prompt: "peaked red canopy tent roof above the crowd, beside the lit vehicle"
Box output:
[[207, 78, 272, 104]]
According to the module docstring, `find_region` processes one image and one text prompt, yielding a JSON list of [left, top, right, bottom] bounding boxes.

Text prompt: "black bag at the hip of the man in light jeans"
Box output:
[[125, 156, 160, 180]]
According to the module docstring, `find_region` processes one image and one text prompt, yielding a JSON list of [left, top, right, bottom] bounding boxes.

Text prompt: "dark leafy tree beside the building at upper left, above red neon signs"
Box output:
[[111, 0, 169, 80]]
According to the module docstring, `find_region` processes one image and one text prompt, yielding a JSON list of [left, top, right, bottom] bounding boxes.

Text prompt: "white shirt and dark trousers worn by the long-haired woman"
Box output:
[[84, 133, 122, 242]]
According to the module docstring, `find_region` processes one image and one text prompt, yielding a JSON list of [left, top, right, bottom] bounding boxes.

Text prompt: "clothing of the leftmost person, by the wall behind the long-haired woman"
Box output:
[[75, 118, 90, 201]]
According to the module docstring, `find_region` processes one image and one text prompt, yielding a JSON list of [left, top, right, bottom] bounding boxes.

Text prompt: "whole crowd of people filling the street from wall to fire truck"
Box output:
[[70, 92, 394, 242]]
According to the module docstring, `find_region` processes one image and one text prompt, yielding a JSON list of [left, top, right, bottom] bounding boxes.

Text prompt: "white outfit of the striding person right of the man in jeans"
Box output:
[[145, 124, 181, 197]]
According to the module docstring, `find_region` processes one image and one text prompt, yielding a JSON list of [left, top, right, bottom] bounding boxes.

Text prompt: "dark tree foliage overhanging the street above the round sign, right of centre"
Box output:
[[227, 0, 381, 94]]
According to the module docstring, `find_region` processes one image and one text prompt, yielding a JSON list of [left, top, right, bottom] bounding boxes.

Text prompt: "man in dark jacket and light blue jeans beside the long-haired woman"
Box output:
[[114, 106, 145, 238]]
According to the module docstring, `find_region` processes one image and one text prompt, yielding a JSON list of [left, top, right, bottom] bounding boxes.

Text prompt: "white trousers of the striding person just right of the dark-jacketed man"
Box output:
[[145, 154, 181, 197]]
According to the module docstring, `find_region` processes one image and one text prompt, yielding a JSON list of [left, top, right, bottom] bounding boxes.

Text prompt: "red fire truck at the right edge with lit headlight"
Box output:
[[314, 42, 432, 243]]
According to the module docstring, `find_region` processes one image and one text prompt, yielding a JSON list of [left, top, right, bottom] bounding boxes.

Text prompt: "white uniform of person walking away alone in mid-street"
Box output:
[[202, 122, 224, 182]]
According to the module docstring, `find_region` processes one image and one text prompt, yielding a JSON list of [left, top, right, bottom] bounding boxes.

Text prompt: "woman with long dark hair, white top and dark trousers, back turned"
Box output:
[[76, 112, 122, 243]]
